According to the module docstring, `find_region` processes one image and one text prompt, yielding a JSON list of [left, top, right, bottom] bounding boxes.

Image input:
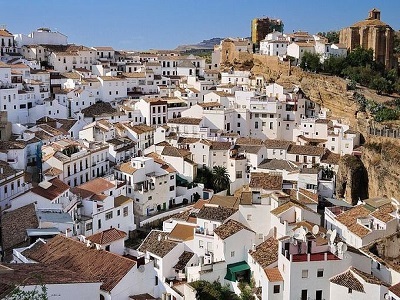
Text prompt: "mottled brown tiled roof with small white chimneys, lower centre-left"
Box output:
[[138, 230, 177, 257]]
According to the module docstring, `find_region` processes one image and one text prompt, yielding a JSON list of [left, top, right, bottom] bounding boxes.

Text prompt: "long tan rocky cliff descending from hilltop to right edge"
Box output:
[[235, 54, 400, 202]]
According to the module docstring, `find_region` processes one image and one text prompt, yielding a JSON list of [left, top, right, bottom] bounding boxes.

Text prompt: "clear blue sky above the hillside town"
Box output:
[[0, 0, 400, 50]]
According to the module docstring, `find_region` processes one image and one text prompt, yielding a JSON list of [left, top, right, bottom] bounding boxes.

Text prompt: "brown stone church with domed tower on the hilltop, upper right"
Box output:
[[339, 8, 394, 69]]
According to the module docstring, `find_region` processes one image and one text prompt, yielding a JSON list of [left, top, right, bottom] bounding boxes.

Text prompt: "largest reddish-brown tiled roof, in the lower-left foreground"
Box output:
[[22, 235, 136, 292]]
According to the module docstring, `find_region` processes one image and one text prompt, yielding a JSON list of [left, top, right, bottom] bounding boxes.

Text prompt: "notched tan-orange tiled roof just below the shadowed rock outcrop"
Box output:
[[336, 205, 371, 237]]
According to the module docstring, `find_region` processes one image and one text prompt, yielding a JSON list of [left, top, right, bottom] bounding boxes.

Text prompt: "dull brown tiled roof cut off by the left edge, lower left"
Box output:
[[1, 203, 39, 251]]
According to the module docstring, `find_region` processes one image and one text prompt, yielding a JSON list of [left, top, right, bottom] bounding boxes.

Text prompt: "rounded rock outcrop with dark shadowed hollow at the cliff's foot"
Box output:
[[336, 155, 369, 205]]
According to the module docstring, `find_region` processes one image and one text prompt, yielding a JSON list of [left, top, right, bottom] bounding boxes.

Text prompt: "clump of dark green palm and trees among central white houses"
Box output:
[[194, 166, 230, 193]]
